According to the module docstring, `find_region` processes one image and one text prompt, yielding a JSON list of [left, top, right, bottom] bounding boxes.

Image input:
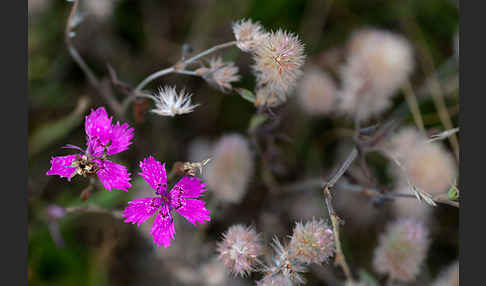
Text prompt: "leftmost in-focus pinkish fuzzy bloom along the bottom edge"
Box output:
[[218, 224, 263, 276]]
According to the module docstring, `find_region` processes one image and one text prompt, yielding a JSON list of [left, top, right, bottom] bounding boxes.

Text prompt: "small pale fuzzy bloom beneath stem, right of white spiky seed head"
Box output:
[[202, 57, 240, 92]]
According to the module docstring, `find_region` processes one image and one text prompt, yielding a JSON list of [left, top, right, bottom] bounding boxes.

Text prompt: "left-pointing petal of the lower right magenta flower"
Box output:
[[122, 198, 162, 226]]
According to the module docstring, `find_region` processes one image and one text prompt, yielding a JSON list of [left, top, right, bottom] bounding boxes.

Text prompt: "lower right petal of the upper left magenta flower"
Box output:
[[95, 160, 132, 192]]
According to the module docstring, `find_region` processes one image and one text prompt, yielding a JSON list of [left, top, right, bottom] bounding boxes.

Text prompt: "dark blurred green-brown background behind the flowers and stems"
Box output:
[[28, 0, 459, 285]]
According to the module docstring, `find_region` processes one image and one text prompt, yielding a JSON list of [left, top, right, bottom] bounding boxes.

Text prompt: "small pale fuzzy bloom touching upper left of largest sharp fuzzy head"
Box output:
[[233, 19, 266, 52]]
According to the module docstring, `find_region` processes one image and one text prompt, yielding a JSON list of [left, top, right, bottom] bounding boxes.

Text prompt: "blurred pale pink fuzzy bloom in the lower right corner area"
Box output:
[[373, 219, 429, 282]]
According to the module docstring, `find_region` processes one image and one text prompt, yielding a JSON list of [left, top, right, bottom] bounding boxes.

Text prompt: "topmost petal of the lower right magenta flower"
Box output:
[[138, 156, 167, 195]]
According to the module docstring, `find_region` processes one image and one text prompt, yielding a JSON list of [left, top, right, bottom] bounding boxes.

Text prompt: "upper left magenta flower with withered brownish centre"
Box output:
[[46, 107, 133, 191]]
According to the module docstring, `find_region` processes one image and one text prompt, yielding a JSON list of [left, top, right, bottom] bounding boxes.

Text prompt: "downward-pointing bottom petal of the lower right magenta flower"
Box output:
[[150, 205, 175, 248]]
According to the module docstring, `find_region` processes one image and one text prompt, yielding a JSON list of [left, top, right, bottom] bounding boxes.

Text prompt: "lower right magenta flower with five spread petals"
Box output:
[[122, 156, 211, 248]]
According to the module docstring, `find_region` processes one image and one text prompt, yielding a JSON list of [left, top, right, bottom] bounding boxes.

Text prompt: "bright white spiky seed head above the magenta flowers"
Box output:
[[151, 86, 199, 117]]
